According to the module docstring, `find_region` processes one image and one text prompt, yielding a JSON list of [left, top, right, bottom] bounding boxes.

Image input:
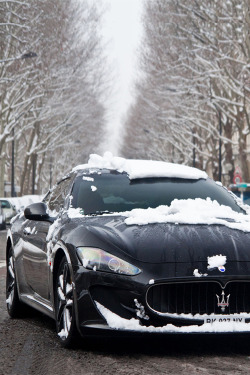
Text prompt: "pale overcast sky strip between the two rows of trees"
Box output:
[[99, 0, 143, 155]]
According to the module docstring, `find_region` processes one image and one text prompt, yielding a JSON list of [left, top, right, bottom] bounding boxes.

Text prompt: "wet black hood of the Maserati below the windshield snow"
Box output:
[[65, 216, 250, 263]]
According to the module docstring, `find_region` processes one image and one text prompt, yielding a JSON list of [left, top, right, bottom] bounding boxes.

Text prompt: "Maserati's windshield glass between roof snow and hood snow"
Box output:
[[71, 171, 244, 215]]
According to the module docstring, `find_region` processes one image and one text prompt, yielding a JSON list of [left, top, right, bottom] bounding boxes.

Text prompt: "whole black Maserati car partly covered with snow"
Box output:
[[6, 158, 250, 347]]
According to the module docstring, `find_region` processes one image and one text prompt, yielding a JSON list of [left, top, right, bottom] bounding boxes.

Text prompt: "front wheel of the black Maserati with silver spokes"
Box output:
[[55, 257, 79, 348]]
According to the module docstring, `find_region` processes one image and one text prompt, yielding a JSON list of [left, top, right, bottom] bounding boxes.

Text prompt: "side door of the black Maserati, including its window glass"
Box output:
[[23, 178, 71, 300]]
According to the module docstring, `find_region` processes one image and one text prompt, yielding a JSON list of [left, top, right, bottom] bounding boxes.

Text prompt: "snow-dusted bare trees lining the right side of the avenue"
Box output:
[[123, 0, 250, 183]]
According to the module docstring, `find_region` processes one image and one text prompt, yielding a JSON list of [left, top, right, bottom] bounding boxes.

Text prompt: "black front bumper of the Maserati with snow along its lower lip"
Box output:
[[75, 267, 250, 335]]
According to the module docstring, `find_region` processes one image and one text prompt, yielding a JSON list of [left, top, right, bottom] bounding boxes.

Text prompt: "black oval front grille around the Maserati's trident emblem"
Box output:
[[147, 281, 250, 315]]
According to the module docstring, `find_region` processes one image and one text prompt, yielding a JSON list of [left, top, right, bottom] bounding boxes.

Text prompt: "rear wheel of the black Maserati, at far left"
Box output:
[[6, 248, 25, 318]]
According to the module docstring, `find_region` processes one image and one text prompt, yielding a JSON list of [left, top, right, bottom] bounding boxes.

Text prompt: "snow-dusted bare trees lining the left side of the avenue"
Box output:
[[0, 0, 107, 196]]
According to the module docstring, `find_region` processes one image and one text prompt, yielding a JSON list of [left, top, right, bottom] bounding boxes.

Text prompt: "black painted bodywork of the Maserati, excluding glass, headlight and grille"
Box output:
[[9, 168, 250, 333]]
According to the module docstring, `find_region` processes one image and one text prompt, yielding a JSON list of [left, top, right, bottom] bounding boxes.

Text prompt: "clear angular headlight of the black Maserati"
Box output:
[[77, 247, 141, 276]]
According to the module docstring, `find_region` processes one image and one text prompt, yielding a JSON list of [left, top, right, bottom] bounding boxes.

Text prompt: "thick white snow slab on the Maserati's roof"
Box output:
[[73, 152, 208, 180]]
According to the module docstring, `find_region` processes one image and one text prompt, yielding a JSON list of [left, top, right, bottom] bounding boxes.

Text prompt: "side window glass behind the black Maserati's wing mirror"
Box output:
[[45, 176, 72, 213]]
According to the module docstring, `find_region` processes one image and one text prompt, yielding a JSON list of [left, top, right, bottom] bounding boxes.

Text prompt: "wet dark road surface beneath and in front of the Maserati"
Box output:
[[0, 232, 250, 375]]
